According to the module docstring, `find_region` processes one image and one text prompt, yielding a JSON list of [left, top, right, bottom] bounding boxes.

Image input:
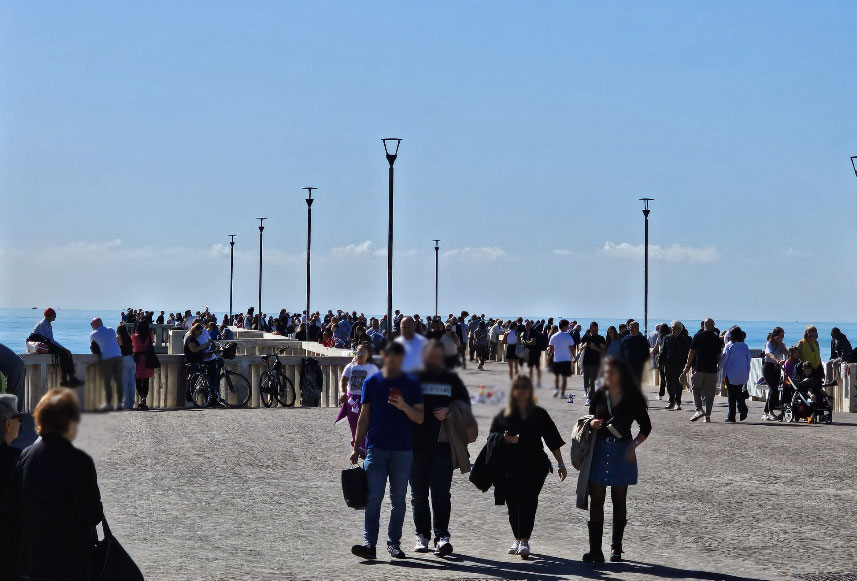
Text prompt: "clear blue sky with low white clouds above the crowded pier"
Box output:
[[0, 1, 857, 321]]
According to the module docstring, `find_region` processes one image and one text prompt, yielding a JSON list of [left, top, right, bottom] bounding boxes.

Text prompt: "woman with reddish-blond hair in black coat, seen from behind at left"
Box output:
[[16, 389, 102, 581]]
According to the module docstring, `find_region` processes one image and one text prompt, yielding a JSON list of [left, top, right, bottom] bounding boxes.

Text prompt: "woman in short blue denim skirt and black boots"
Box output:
[[583, 357, 652, 563]]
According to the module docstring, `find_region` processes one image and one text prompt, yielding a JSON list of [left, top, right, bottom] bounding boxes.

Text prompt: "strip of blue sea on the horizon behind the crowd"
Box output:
[[0, 309, 857, 360]]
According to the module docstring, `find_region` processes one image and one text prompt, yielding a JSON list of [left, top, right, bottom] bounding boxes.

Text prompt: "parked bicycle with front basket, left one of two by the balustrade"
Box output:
[[186, 343, 251, 408]]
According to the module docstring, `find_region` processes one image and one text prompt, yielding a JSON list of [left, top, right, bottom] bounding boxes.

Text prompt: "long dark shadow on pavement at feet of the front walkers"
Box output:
[[376, 555, 764, 581]]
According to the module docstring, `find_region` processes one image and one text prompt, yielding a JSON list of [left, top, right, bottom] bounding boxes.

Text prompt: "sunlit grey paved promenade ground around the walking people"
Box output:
[[77, 363, 857, 581]]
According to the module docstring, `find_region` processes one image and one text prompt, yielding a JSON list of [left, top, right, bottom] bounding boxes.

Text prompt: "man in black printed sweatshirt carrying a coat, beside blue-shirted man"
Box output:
[[410, 341, 470, 557]]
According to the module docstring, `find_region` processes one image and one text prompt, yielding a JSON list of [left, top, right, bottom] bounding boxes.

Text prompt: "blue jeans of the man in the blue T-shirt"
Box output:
[[363, 448, 414, 547]]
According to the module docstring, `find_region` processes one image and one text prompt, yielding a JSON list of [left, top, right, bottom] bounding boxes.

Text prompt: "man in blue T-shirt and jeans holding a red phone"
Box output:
[[349, 342, 424, 559]]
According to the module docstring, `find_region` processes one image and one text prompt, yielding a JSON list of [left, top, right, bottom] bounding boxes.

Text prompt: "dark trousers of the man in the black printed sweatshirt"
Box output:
[[410, 444, 452, 540]]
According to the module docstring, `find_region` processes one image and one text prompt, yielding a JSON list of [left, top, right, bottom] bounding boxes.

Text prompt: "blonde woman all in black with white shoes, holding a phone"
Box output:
[[489, 376, 568, 559]]
